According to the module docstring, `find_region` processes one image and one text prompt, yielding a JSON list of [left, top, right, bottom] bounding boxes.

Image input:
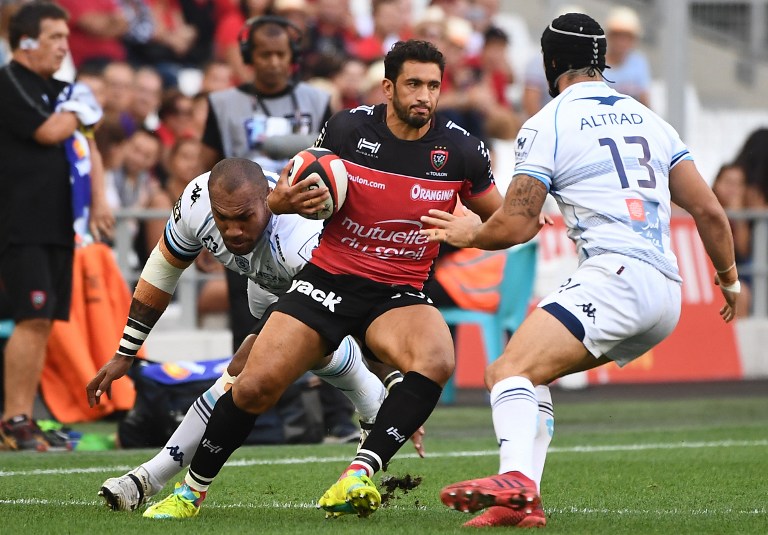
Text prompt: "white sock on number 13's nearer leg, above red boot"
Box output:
[[491, 377, 539, 477]]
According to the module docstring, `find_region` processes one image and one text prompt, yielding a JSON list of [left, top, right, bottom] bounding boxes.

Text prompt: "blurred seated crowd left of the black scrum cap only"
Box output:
[[0, 0, 536, 318]]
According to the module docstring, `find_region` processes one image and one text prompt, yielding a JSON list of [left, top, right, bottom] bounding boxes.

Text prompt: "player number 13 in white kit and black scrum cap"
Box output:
[[422, 13, 740, 527]]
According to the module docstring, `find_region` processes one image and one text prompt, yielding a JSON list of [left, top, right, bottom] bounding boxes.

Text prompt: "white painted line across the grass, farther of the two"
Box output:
[[0, 439, 768, 480]]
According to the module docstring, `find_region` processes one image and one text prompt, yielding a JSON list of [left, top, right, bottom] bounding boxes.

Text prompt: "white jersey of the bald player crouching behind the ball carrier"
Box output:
[[165, 172, 323, 295]]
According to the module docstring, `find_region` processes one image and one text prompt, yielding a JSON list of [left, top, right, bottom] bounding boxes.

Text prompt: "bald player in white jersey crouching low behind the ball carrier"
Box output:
[[87, 158, 402, 510]]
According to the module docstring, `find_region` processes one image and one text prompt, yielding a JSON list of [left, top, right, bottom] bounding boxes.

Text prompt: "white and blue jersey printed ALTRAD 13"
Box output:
[[514, 82, 691, 281]]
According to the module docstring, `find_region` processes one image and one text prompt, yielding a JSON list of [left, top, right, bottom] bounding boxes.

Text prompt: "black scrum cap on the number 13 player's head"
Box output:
[[541, 13, 606, 97]]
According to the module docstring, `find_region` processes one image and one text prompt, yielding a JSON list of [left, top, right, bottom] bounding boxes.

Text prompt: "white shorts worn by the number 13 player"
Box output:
[[538, 254, 681, 366]]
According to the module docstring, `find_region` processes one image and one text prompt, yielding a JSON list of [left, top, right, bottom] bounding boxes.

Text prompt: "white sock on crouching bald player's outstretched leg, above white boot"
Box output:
[[141, 371, 234, 491]]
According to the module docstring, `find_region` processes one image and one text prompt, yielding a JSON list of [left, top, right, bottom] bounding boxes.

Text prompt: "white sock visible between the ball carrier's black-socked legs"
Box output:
[[312, 336, 386, 421]]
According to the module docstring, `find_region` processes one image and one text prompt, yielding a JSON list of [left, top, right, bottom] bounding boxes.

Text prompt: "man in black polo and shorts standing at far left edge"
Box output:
[[0, 2, 106, 451]]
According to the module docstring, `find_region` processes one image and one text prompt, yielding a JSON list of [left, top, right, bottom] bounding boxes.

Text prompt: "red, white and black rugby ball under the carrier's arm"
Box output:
[[288, 147, 347, 219]]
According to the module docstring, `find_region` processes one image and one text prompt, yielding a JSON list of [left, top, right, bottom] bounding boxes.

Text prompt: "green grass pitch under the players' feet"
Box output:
[[0, 391, 768, 535]]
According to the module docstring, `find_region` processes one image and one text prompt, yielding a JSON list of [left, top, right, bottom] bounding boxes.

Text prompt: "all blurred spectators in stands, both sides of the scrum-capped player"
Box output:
[[0, 0, 756, 456]]
